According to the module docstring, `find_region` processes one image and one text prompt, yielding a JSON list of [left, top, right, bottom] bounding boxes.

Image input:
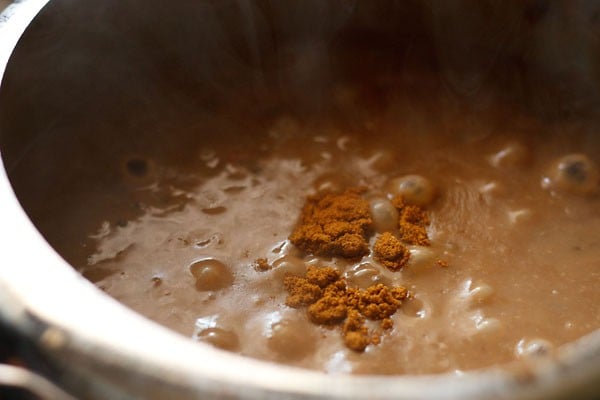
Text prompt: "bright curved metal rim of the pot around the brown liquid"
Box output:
[[0, 0, 600, 399]]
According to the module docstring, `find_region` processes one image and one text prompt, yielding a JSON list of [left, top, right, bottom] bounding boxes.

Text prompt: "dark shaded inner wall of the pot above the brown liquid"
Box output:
[[0, 0, 600, 288]]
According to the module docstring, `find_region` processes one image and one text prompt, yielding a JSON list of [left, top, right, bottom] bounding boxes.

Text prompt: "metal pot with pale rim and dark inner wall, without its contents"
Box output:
[[0, 0, 600, 399]]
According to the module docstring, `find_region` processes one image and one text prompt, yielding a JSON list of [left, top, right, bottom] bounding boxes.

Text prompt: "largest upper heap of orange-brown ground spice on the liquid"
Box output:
[[290, 189, 373, 258]]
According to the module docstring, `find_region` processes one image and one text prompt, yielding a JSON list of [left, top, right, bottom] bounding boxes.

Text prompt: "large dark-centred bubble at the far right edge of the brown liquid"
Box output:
[[542, 154, 600, 195]]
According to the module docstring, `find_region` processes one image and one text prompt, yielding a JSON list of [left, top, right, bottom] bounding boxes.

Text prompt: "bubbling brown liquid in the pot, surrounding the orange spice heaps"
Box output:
[[64, 103, 600, 374]]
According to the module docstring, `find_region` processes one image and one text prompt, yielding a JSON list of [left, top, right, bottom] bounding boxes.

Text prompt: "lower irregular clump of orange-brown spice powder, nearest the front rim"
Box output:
[[284, 266, 408, 352]]
